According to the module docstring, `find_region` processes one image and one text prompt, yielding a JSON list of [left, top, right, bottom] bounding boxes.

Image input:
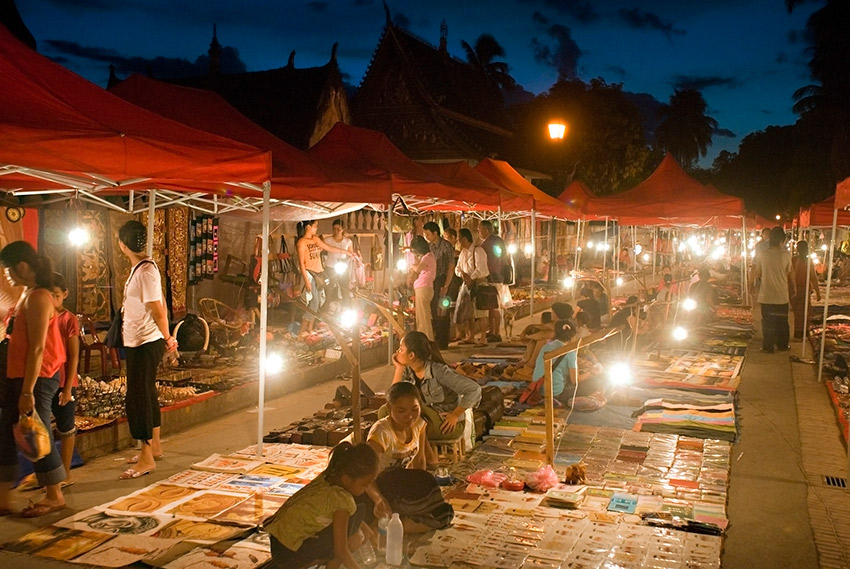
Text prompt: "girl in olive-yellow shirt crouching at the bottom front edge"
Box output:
[[264, 442, 378, 569]]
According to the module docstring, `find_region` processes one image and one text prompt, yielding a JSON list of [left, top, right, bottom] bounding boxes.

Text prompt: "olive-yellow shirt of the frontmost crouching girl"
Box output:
[[264, 473, 357, 551]]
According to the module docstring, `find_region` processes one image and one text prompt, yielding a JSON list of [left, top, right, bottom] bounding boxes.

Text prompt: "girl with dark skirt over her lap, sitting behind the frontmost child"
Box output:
[[366, 381, 454, 534]]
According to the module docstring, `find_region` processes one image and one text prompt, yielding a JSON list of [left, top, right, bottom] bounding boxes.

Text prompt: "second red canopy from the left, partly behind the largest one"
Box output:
[[110, 75, 391, 203]]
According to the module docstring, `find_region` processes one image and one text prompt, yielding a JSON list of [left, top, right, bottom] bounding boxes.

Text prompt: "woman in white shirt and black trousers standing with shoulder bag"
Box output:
[[118, 220, 177, 480]]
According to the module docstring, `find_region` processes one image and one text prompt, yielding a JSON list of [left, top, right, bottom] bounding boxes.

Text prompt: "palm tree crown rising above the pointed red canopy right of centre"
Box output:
[[655, 89, 717, 167]]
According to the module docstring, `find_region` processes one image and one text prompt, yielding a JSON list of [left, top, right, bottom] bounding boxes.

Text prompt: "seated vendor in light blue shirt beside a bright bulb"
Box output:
[[531, 320, 605, 411]]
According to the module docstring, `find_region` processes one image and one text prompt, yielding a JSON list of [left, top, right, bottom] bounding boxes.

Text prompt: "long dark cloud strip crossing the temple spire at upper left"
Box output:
[[45, 40, 246, 79]]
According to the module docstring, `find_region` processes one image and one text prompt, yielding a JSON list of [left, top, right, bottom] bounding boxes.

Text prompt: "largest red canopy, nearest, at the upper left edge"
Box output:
[[0, 26, 271, 193]]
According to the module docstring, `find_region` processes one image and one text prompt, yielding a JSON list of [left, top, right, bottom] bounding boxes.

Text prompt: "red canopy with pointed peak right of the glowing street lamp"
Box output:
[[587, 154, 744, 225]]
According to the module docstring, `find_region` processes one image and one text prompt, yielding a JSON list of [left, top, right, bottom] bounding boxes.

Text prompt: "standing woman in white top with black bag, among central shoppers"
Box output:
[[454, 227, 490, 346]]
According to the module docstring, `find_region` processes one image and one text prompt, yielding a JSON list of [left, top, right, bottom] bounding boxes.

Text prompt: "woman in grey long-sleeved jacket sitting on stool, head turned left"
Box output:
[[393, 332, 481, 450]]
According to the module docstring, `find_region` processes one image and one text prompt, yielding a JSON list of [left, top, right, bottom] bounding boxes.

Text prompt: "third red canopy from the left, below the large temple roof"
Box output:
[[307, 122, 499, 206]]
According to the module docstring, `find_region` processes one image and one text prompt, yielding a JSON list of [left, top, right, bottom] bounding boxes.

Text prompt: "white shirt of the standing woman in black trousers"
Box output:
[[121, 259, 162, 348]]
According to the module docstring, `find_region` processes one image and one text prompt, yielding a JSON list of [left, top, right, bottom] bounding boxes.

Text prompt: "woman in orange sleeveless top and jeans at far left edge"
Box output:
[[0, 241, 65, 518]]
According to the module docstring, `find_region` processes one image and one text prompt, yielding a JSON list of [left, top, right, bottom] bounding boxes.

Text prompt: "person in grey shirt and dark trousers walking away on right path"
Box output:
[[753, 227, 797, 354]]
